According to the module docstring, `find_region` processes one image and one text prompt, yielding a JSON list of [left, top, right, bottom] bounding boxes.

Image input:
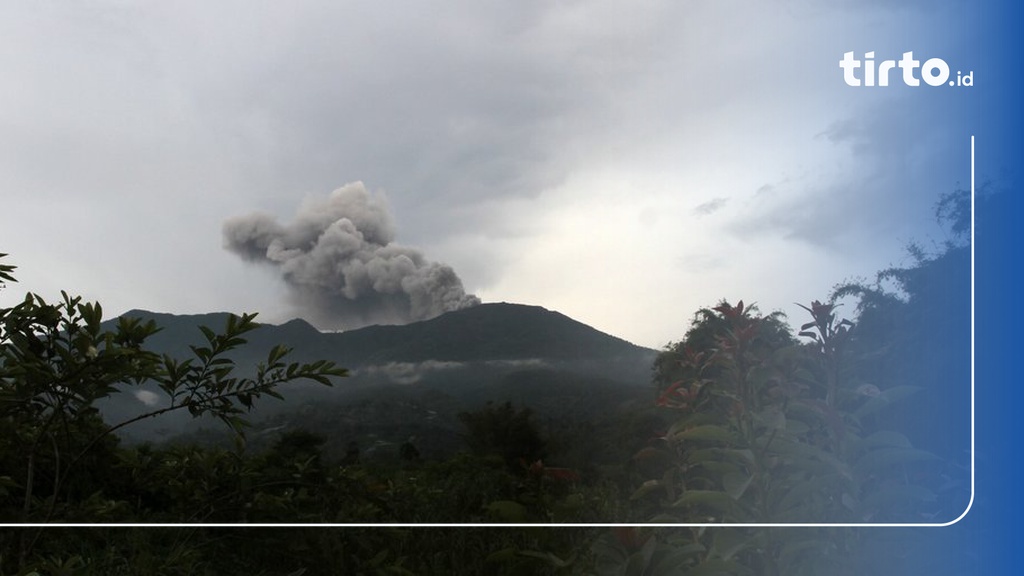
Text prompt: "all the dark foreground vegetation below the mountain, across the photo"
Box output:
[[0, 187, 970, 576]]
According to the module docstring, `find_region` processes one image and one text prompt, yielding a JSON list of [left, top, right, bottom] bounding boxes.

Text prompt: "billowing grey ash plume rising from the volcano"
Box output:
[[223, 182, 480, 329]]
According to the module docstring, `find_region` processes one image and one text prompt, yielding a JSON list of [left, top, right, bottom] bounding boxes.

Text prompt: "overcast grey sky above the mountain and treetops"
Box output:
[[0, 0, 994, 347]]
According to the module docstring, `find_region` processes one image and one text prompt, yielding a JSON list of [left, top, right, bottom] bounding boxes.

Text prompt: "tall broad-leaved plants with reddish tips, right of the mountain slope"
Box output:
[[614, 301, 935, 575]]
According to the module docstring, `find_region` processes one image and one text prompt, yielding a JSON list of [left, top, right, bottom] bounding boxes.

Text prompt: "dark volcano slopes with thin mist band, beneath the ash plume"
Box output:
[[103, 303, 656, 452]]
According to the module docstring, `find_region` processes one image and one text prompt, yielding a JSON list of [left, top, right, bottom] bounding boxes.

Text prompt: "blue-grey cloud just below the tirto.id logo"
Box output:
[[730, 89, 970, 249]]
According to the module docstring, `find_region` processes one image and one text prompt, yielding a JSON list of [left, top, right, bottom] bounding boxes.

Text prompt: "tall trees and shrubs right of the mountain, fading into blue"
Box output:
[[605, 187, 970, 575]]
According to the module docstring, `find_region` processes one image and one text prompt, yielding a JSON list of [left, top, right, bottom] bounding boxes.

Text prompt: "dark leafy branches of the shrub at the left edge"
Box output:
[[0, 254, 347, 559]]
